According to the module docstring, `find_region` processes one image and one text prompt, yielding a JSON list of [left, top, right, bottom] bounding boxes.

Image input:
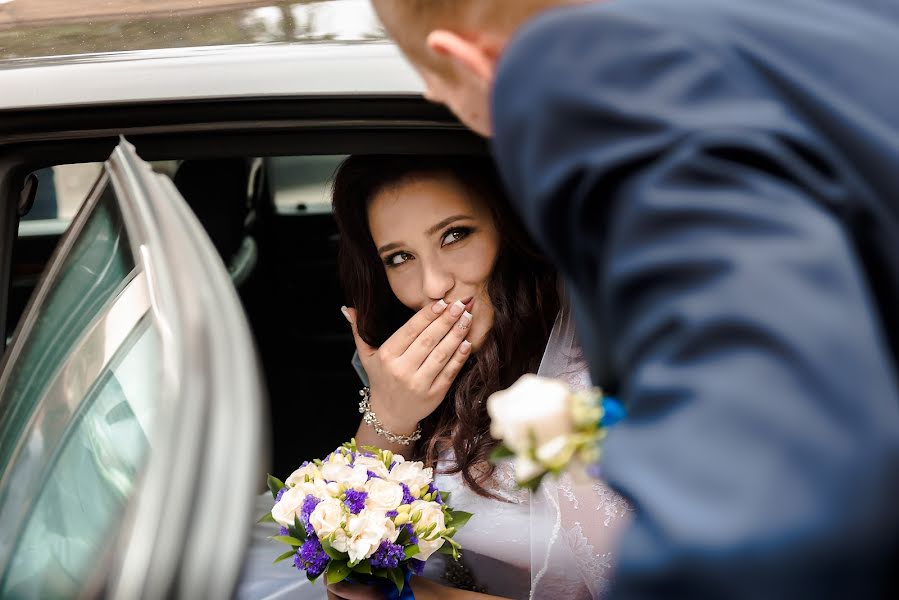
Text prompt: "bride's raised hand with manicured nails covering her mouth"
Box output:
[[344, 300, 472, 435]]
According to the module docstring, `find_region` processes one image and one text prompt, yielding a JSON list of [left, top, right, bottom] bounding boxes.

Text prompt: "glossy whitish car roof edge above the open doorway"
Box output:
[[0, 41, 422, 111]]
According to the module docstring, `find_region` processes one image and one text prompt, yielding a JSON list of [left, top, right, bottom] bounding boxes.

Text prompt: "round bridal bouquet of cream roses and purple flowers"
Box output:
[[263, 440, 471, 598]]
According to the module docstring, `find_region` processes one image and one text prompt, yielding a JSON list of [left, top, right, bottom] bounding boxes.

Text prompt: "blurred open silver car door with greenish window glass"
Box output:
[[0, 140, 266, 598]]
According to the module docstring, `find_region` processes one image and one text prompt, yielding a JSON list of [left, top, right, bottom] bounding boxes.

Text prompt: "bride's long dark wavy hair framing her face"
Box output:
[[333, 156, 559, 497]]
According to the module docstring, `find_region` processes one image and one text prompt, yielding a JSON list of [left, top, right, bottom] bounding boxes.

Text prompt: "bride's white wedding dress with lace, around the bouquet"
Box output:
[[237, 298, 630, 600]]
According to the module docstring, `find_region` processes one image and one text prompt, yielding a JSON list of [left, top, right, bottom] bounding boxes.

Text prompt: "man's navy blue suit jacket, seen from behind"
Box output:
[[493, 0, 899, 599]]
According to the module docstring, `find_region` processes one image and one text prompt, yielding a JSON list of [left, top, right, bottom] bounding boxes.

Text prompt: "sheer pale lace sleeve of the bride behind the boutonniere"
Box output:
[[531, 286, 631, 599]]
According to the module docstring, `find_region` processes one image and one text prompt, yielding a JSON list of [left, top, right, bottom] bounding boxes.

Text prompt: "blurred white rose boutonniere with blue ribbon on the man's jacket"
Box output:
[[487, 375, 624, 490]]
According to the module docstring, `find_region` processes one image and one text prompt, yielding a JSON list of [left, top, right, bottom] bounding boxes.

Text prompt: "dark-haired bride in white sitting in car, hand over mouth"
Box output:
[[239, 156, 629, 600]]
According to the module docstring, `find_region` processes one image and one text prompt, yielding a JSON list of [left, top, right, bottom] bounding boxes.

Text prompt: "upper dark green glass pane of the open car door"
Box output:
[[0, 187, 135, 474]]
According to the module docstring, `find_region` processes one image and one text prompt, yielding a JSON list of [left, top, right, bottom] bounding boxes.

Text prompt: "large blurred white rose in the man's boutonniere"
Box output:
[[487, 374, 572, 454]]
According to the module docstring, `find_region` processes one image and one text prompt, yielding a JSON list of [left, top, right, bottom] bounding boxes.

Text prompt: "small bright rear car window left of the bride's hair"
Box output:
[[266, 155, 346, 214]]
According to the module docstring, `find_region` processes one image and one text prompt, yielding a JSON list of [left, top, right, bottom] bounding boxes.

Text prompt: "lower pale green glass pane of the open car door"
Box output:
[[0, 318, 161, 598]]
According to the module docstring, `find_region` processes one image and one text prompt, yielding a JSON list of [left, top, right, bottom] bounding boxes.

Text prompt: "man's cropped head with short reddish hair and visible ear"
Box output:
[[372, 0, 590, 136]]
